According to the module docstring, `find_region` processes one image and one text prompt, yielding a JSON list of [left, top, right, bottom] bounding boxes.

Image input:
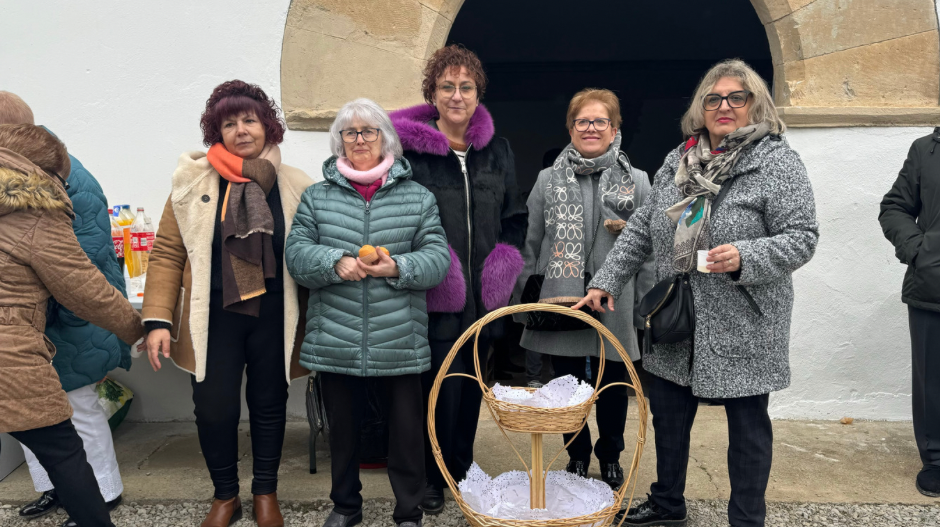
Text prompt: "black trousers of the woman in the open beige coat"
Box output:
[[192, 291, 288, 500]]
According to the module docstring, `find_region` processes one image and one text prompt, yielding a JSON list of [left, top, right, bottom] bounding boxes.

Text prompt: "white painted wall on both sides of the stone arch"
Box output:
[[0, 0, 940, 421]]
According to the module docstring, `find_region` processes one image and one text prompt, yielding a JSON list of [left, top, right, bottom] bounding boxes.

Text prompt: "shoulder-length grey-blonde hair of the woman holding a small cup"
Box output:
[[682, 59, 787, 138]]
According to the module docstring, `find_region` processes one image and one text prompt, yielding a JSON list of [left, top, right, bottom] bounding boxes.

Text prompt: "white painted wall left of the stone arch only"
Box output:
[[0, 0, 329, 421]]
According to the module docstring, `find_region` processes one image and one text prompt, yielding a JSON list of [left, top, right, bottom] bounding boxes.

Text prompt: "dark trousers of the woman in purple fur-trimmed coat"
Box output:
[[421, 338, 491, 489]]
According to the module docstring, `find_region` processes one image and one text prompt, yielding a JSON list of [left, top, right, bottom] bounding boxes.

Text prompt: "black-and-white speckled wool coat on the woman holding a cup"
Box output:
[[589, 136, 819, 398]]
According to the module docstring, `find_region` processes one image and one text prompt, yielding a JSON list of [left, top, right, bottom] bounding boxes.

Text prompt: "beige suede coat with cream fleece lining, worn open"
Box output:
[[143, 152, 313, 383]]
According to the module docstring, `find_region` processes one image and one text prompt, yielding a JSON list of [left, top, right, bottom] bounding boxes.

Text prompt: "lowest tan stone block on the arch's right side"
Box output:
[[787, 30, 940, 107]]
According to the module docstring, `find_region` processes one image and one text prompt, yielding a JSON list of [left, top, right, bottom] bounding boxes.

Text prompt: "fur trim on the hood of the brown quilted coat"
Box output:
[[0, 167, 72, 216]]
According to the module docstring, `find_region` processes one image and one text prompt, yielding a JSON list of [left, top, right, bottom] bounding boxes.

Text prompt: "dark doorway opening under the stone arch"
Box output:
[[448, 0, 773, 192]]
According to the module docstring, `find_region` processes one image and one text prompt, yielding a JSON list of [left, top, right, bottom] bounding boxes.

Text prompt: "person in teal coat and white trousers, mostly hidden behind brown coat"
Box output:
[[0, 91, 131, 527]]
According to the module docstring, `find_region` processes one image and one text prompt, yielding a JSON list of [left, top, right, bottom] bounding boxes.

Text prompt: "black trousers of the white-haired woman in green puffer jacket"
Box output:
[[318, 372, 424, 524]]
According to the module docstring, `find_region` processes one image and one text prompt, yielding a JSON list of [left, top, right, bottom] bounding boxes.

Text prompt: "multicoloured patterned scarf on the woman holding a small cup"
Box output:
[[666, 123, 770, 273]]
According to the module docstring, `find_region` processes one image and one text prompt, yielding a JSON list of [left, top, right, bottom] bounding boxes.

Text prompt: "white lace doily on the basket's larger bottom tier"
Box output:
[[457, 462, 615, 527]]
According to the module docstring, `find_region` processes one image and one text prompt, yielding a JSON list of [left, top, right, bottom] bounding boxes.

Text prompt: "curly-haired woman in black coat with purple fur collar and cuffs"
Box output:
[[391, 45, 526, 514]]
